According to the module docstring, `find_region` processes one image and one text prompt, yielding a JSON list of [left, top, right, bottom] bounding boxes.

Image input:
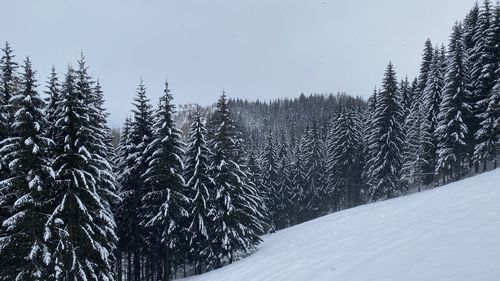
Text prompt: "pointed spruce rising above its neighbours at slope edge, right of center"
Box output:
[[369, 63, 405, 200]]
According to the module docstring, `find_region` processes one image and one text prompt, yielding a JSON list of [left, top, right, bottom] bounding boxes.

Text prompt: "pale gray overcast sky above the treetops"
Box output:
[[0, 0, 475, 126]]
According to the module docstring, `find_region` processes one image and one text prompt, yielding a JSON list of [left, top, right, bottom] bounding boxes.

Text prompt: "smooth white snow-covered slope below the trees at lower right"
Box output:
[[185, 169, 500, 281]]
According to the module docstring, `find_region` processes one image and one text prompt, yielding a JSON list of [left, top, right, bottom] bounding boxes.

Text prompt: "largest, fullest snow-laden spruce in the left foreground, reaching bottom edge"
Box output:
[[46, 62, 116, 280]]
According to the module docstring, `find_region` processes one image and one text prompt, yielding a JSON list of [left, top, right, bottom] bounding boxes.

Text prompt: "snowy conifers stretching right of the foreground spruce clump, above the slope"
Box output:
[[239, 0, 500, 234]]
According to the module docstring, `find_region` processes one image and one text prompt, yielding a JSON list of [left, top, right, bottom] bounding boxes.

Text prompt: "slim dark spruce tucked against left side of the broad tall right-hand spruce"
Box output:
[[419, 47, 444, 185]]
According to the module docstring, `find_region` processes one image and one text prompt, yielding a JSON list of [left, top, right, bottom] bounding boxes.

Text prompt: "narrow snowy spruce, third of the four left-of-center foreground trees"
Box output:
[[184, 111, 215, 274]]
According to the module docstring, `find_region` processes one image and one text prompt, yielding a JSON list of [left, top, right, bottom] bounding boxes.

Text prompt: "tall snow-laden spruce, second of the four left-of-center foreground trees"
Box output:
[[141, 82, 189, 280]]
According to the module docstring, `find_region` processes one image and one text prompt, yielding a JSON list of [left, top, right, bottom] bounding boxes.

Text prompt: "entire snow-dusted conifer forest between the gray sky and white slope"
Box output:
[[0, 0, 500, 281]]
